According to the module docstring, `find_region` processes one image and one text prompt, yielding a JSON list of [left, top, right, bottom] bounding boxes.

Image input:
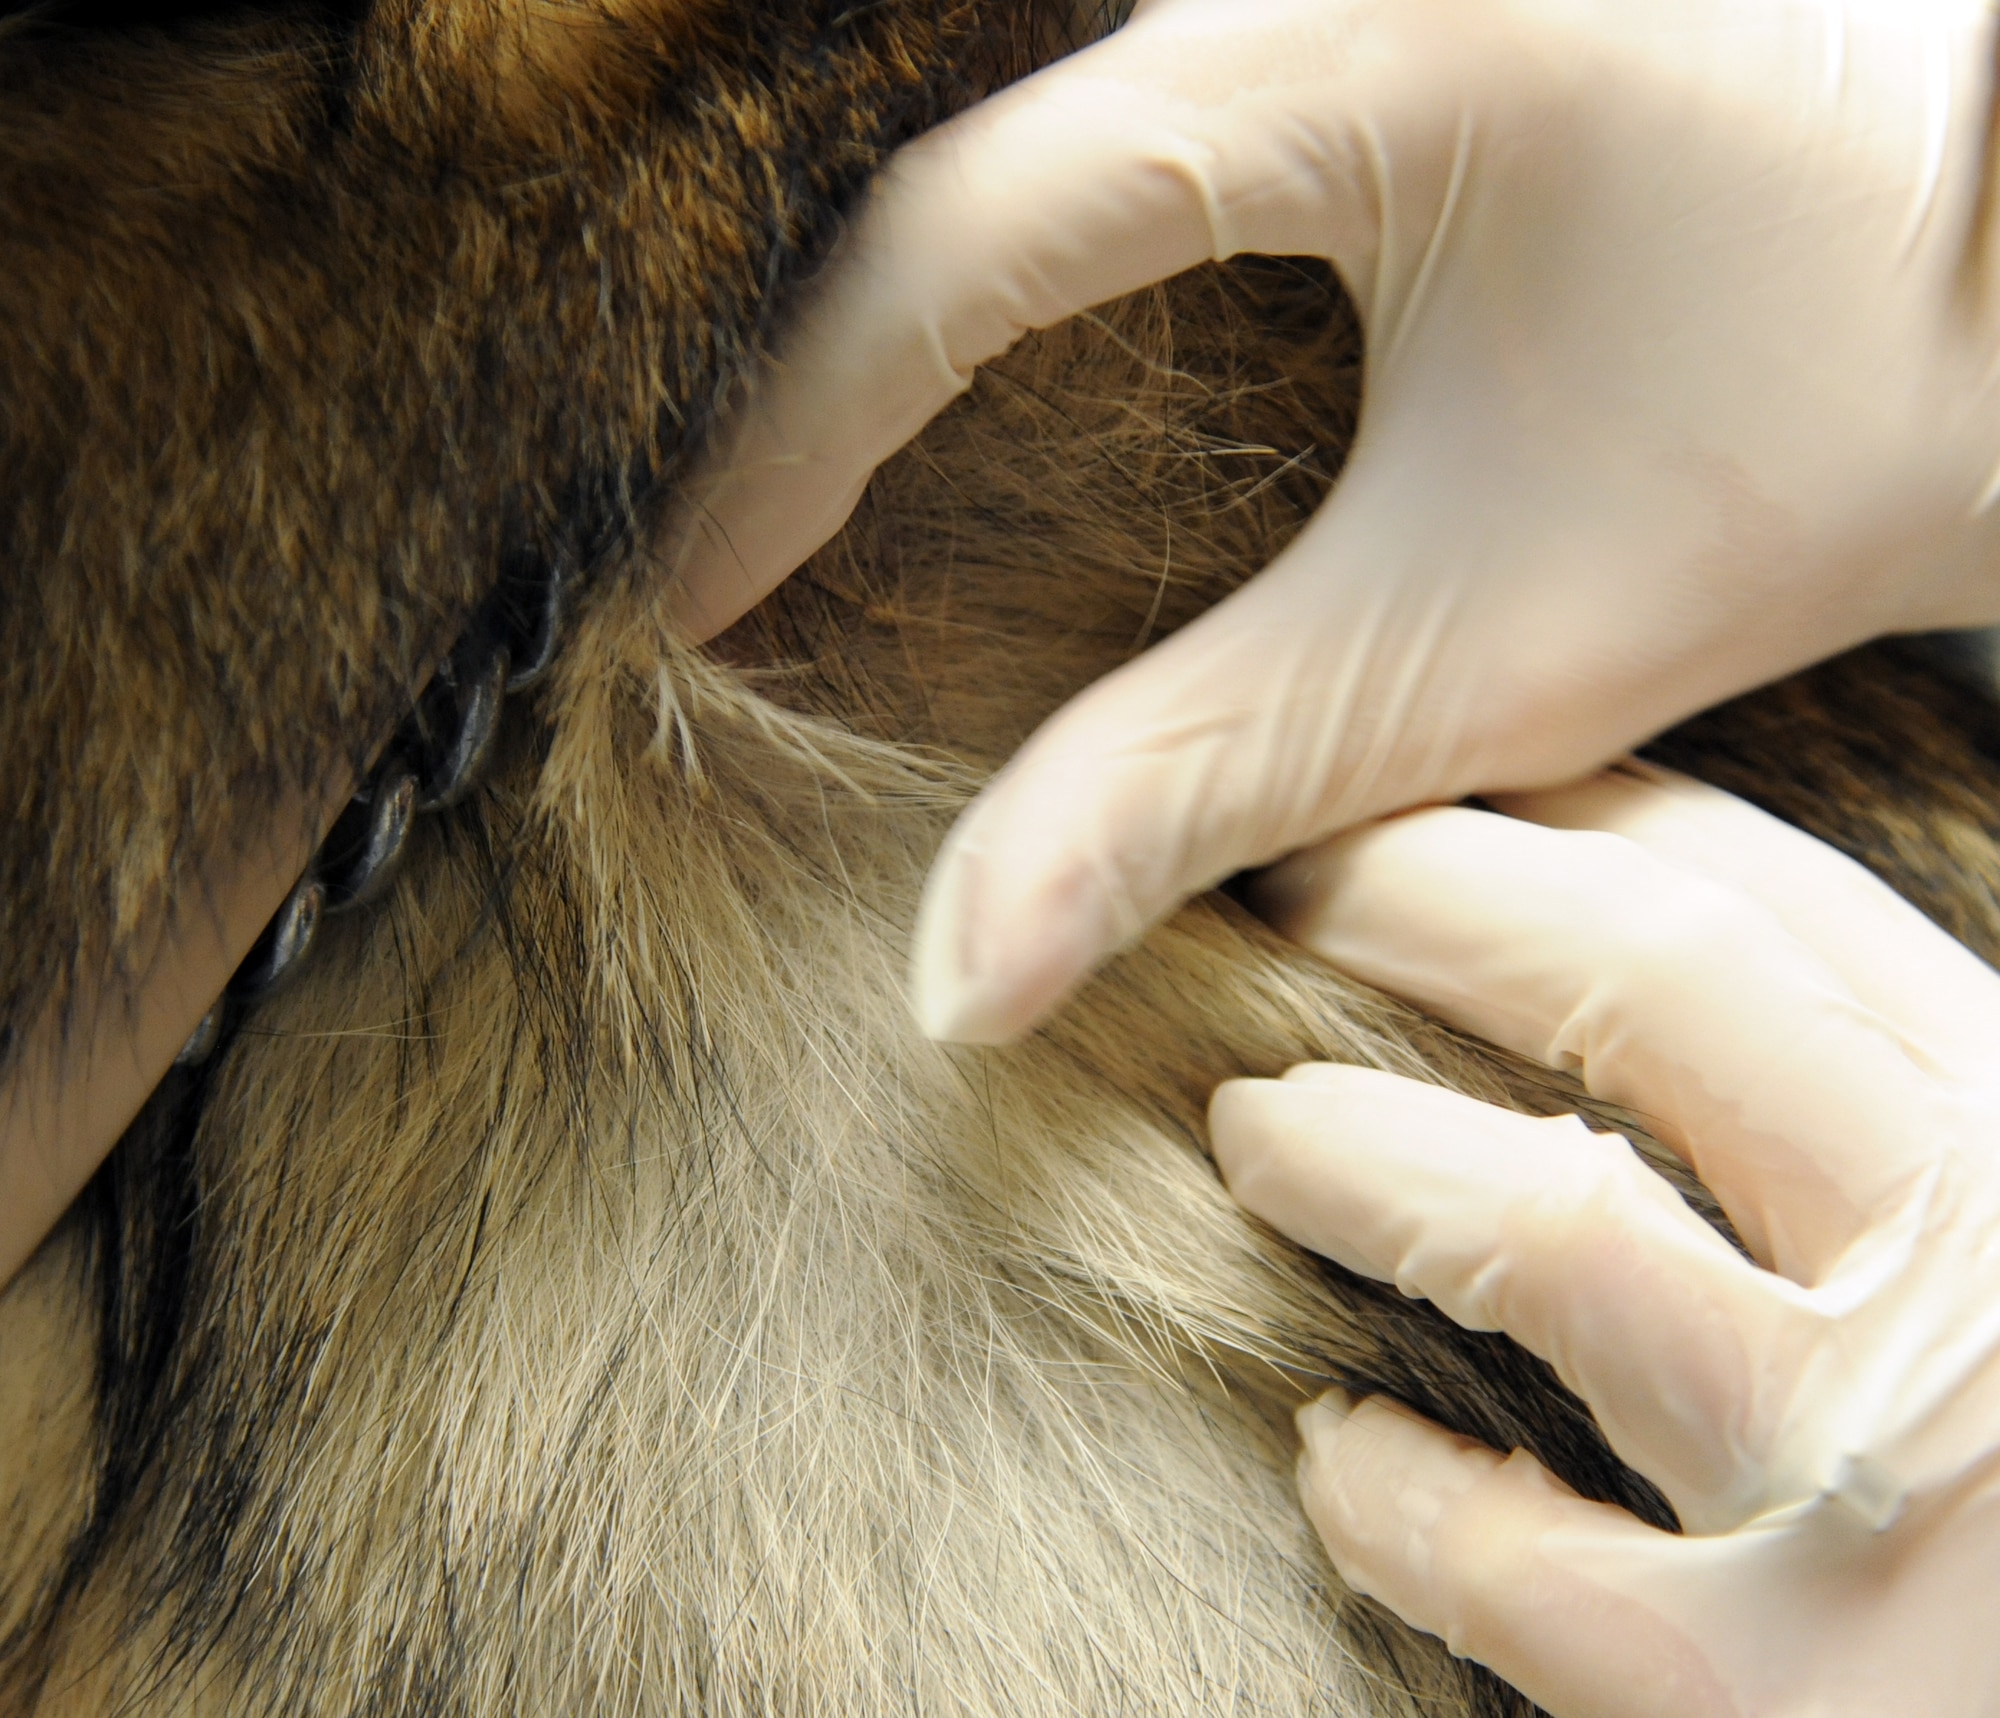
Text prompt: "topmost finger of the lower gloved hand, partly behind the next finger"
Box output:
[[1492, 760, 2000, 1084]]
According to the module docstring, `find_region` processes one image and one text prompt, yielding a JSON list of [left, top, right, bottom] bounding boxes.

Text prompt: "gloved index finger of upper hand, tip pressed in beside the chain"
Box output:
[[672, 0, 1478, 638]]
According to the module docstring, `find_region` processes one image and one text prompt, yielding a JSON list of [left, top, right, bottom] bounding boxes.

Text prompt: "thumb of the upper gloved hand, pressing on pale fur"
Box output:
[[914, 496, 1496, 1044]]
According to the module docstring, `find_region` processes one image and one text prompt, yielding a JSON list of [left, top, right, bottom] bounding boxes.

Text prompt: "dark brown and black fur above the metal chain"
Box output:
[[0, 0, 1080, 1048]]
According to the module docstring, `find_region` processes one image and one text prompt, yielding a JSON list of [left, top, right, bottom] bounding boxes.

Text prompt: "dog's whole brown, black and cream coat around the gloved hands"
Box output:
[[11, 6, 2000, 1718]]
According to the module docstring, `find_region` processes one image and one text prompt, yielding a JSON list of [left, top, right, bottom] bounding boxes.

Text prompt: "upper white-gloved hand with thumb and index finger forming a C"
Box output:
[[680, 0, 2000, 1042]]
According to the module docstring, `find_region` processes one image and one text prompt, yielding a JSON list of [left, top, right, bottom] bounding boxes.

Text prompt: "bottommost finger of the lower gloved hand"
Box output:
[[1298, 1398, 1742, 1718]]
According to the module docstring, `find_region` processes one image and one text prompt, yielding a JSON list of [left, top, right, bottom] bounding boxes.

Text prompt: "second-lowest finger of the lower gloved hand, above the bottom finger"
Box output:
[[1210, 1064, 1812, 1528]]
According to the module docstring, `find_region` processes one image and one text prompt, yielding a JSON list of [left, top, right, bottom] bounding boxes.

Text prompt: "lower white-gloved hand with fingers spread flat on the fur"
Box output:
[[1210, 772, 2000, 1718]]
